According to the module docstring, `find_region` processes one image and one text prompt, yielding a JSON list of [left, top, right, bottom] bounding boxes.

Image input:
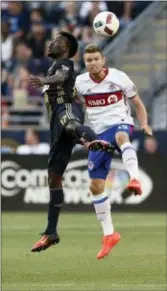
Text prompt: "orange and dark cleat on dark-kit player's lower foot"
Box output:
[[31, 234, 60, 252]]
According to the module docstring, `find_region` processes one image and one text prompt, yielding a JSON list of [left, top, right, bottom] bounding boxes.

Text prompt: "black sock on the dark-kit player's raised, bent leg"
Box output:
[[75, 125, 98, 142]]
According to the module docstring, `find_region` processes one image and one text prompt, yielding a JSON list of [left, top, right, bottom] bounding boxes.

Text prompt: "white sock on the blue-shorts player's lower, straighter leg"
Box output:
[[92, 192, 114, 236]]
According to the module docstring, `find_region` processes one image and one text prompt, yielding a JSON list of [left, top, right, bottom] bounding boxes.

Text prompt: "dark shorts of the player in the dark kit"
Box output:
[[48, 103, 84, 176]]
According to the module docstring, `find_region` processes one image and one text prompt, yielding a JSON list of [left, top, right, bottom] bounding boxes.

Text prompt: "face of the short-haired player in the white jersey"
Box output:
[[84, 52, 105, 74]]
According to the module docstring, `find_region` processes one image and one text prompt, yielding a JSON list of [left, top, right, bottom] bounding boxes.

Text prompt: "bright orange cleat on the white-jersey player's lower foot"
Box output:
[[97, 232, 121, 260]]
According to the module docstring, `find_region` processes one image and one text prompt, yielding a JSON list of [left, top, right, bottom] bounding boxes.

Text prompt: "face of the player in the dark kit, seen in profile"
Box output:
[[48, 34, 67, 59]]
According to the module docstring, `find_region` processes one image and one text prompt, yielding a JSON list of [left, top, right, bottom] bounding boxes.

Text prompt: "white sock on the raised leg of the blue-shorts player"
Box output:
[[120, 142, 139, 179]]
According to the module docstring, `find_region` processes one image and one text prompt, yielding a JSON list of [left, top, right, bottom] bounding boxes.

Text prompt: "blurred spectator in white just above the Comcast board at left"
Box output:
[[16, 128, 49, 155]]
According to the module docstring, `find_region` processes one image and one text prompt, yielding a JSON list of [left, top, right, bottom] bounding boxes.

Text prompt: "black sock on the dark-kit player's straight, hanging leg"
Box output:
[[45, 189, 64, 234]]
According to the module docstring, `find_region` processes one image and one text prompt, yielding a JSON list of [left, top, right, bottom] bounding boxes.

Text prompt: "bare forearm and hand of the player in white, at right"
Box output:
[[131, 95, 152, 135]]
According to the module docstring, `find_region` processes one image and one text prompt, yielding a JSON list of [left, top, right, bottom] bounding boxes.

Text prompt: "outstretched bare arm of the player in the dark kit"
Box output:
[[29, 70, 69, 88]]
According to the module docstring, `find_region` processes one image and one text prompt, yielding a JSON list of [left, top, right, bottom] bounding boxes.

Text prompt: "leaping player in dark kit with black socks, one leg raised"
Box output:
[[30, 32, 112, 252]]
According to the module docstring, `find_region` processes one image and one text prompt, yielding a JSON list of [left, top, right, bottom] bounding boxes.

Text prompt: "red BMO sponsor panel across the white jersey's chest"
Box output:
[[85, 91, 123, 107]]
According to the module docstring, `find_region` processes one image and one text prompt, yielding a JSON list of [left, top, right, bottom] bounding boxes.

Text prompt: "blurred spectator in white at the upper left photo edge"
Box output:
[[1, 21, 13, 62]]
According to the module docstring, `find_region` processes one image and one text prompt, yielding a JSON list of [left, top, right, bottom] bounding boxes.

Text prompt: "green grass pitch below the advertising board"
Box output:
[[2, 212, 167, 291]]
